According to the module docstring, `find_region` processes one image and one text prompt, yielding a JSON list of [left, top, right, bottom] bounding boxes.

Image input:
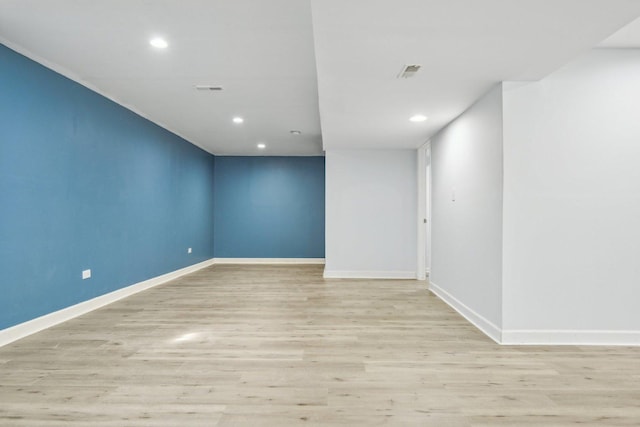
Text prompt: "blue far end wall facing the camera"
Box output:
[[214, 156, 325, 258]]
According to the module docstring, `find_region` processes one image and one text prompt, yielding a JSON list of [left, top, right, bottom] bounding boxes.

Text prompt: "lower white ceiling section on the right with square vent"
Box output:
[[312, 0, 640, 149]]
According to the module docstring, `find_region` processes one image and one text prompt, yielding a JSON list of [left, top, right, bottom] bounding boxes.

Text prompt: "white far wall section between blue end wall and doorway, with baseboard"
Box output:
[[325, 150, 417, 278]]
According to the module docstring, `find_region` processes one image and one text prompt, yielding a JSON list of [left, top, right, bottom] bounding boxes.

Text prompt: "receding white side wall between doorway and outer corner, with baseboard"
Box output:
[[429, 85, 502, 341]]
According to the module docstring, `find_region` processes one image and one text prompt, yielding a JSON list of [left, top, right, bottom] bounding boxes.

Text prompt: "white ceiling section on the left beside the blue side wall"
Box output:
[[0, 0, 322, 155]]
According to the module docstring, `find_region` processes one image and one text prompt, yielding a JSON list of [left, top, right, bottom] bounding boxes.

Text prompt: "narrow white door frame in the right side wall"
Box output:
[[417, 140, 432, 280]]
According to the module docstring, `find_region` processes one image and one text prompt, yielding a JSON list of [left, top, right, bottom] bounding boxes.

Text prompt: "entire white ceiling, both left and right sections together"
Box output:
[[0, 0, 640, 155]]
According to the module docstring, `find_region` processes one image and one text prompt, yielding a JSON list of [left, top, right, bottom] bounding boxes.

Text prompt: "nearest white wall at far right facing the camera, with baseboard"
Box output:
[[504, 49, 640, 344]]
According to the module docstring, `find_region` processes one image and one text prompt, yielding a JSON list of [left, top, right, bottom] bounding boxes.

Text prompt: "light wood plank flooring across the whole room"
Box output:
[[0, 265, 640, 427]]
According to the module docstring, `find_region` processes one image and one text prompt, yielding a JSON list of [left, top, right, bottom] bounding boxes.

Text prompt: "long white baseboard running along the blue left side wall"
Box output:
[[0, 259, 213, 347]]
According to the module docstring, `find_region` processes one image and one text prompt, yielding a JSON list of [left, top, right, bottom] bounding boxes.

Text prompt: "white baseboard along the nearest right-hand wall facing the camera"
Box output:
[[502, 329, 640, 346]]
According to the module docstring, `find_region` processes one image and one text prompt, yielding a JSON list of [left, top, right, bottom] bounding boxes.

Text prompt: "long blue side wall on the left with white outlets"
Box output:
[[0, 45, 214, 329]]
